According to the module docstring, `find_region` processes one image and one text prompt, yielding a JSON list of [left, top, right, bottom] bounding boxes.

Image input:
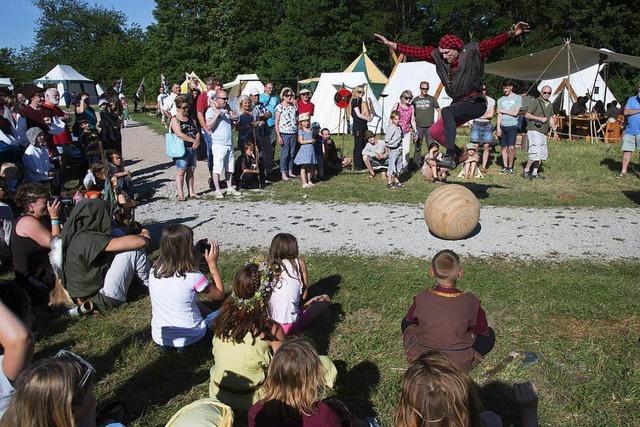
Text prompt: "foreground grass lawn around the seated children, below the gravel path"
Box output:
[[35, 252, 640, 427]]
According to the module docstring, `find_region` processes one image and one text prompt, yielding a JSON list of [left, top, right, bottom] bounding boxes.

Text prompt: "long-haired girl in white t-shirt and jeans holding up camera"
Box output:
[[149, 224, 224, 348]]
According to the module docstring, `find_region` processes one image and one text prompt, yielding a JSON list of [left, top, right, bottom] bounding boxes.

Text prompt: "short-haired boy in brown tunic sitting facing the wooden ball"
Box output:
[[402, 249, 495, 372]]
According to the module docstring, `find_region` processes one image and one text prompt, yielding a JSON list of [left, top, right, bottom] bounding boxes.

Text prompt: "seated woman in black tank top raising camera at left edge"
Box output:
[[10, 182, 60, 300]]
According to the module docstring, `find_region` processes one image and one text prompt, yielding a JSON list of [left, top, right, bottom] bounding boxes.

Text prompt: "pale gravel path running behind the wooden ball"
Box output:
[[123, 126, 640, 259]]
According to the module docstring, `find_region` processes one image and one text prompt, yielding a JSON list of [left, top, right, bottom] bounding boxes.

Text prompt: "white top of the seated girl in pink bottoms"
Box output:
[[269, 259, 302, 325]]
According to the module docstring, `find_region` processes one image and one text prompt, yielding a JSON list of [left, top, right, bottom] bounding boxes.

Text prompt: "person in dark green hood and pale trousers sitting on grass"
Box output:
[[61, 199, 151, 311]]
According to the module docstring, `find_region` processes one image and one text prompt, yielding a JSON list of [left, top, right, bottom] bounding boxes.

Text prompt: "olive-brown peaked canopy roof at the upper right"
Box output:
[[484, 42, 640, 80]]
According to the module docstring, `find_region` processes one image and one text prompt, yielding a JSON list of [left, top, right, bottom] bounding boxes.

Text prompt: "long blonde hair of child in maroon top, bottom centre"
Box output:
[[263, 338, 326, 419]]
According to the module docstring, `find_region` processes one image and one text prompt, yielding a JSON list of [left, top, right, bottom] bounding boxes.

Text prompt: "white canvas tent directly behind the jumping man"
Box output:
[[379, 61, 451, 130]]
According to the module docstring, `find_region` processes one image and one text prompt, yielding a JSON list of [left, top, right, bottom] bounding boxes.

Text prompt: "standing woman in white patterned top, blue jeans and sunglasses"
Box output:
[[275, 87, 298, 181]]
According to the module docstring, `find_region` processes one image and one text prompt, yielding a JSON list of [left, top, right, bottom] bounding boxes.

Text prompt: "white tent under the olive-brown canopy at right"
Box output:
[[538, 64, 616, 114]]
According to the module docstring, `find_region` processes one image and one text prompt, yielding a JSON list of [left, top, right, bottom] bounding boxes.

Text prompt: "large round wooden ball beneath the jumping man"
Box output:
[[424, 184, 480, 240]]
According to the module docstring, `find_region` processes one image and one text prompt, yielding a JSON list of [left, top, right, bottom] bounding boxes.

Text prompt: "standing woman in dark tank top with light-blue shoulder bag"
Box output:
[[170, 96, 200, 202]]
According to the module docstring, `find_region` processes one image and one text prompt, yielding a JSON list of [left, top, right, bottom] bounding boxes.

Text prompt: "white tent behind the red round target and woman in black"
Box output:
[[311, 71, 389, 133]]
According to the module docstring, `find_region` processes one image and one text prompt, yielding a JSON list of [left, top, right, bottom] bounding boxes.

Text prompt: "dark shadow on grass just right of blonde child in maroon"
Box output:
[[335, 360, 380, 418]]
